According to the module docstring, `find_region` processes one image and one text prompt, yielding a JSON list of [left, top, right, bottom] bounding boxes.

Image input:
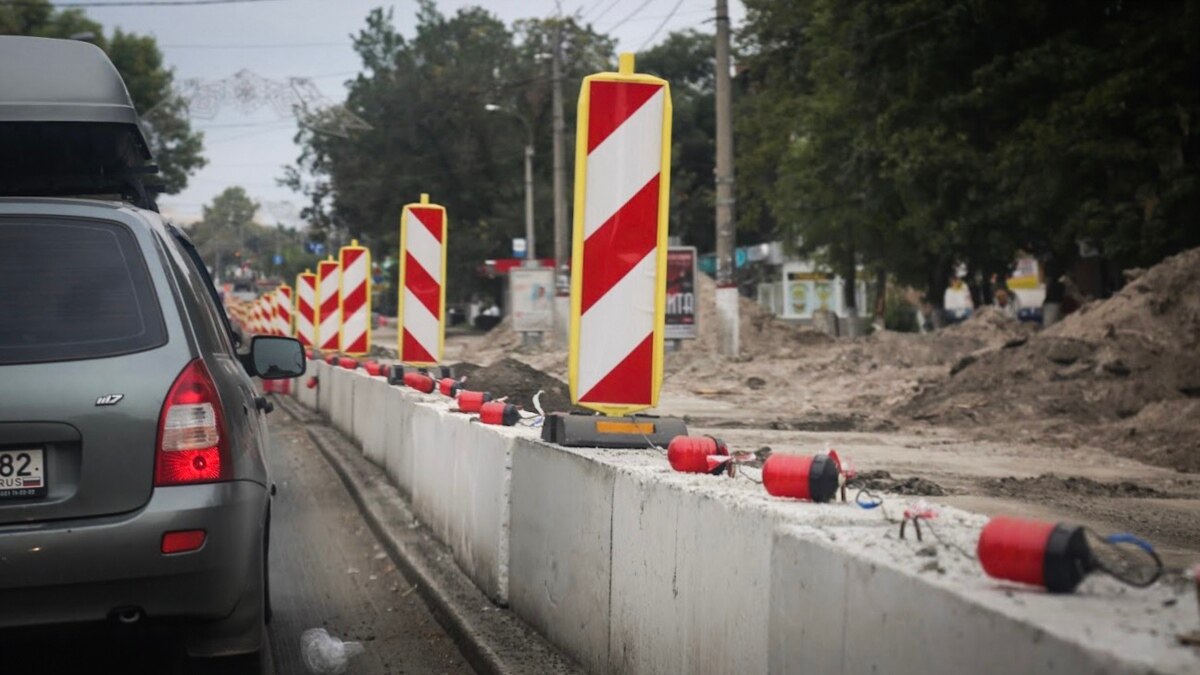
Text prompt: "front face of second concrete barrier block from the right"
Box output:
[[610, 474, 770, 674]]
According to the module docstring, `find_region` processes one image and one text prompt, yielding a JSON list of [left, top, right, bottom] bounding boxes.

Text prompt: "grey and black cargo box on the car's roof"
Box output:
[[0, 36, 156, 208]]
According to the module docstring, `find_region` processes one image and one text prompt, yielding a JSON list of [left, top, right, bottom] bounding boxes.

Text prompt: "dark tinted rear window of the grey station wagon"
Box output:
[[0, 219, 167, 364]]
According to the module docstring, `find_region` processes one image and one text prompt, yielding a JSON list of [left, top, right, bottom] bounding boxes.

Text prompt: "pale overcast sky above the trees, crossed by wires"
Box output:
[[72, 0, 744, 222]]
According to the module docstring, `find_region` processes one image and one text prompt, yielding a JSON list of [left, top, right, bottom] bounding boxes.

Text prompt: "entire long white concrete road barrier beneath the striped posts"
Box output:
[[296, 364, 1200, 674]]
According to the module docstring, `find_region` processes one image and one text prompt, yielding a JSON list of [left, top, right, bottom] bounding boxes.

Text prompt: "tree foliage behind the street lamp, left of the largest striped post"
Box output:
[[286, 0, 614, 299]]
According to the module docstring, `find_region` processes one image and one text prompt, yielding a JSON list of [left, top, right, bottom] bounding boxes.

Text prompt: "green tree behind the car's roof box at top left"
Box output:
[[0, 0, 206, 195]]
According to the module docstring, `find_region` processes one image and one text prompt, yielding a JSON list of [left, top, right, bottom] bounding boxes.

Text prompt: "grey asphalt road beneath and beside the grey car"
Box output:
[[0, 410, 470, 675]]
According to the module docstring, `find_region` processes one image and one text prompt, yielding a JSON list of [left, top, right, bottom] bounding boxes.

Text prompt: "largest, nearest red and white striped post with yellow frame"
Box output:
[[569, 54, 671, 416]]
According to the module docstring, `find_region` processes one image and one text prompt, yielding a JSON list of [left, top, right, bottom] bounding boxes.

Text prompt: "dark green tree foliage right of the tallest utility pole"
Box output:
[[738, 0, 1200, 304]]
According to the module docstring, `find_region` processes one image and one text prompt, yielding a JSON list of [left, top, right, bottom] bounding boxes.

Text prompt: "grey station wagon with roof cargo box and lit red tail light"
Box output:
[[0, 37, 305, 656]]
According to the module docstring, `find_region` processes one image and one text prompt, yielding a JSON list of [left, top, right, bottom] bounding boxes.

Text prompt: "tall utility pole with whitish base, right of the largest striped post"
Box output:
[[715, 0, 739, 357]]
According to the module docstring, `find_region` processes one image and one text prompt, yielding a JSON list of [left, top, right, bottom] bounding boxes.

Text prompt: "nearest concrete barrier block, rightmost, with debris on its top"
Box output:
[[768, 526, 1196, 674]]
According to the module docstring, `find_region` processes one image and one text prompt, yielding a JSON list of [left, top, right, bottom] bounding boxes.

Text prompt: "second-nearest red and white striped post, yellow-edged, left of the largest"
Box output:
[[396, 193, 446, 366]]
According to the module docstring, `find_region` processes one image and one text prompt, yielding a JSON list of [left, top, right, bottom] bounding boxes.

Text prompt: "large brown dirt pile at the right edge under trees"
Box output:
[[899, 243, 1200, 471]]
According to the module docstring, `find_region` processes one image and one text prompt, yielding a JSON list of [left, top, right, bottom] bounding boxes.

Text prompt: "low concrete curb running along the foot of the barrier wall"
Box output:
[[275, 396, 583, 675]]
